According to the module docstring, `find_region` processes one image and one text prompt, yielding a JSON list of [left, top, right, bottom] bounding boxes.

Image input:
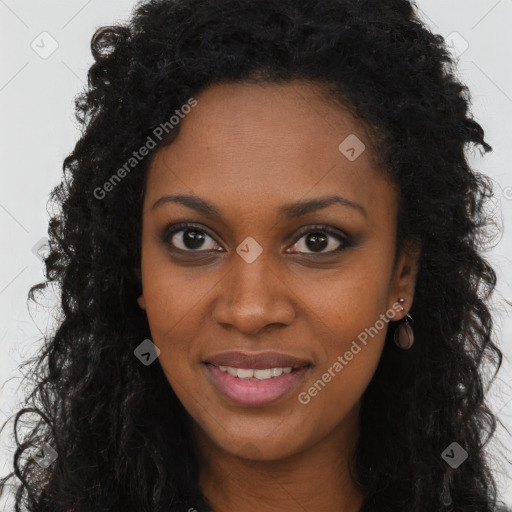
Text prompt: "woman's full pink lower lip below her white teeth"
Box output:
[[205, 363, 311, 407]]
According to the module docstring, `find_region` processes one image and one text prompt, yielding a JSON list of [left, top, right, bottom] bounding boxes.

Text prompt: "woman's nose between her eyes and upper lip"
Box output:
[[213, 252, 295, 336]]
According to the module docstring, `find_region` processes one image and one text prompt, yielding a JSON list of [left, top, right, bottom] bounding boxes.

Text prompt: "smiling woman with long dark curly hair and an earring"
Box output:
[[1, 0, 512, 512]]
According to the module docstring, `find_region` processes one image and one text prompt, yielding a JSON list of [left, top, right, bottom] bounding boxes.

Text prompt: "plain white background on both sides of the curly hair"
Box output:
[[0, 0, 512, 508]]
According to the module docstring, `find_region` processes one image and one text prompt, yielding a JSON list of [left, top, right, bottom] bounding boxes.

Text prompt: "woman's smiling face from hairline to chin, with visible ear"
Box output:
[[139, 81, 416, 459]]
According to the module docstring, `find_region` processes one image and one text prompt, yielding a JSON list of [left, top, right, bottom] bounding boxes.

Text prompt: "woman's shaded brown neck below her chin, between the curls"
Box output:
[[193, 407, 362, 512]]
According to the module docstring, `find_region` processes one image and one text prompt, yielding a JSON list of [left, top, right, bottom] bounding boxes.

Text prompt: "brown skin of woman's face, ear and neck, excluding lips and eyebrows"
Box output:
[[138, 81, 419, 512]]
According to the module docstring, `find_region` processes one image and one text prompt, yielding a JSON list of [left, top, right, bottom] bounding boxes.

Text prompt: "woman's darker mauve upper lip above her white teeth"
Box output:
[[204, 351, 311, 369]]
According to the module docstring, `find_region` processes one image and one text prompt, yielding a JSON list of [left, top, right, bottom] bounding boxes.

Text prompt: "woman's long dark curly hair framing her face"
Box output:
[[2, 0, 512, 512]]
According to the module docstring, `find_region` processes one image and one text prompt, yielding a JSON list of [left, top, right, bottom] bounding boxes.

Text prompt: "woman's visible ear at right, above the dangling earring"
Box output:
[[388, 239, 421, 320]]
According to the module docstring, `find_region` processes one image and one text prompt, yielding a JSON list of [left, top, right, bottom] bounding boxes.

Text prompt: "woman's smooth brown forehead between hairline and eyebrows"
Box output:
[[145, 81, 395, 221]]
